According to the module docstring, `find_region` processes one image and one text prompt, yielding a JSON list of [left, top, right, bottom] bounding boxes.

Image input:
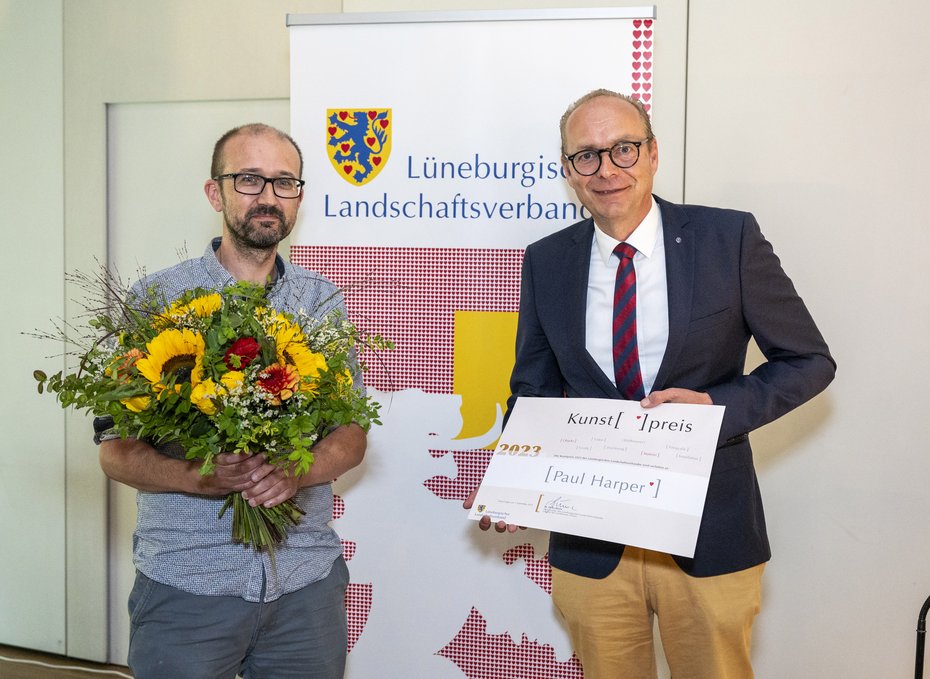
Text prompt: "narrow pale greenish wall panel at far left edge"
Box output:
[[0, 0, 67, 653]]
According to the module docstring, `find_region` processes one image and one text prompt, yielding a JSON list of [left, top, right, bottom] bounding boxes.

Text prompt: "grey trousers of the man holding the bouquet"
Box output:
[[128, 557, 349, 679]]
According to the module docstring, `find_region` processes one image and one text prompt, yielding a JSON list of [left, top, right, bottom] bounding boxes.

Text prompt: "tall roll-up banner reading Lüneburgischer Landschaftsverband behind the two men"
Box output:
[[287, 6, 656, 679]]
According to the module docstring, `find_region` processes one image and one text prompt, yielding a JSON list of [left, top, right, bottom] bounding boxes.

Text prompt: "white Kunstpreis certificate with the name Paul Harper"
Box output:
[[469, 397, 724, 557]]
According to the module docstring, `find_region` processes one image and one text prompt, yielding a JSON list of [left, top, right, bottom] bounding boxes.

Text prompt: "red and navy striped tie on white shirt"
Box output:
[[614, 243, 645, 401]]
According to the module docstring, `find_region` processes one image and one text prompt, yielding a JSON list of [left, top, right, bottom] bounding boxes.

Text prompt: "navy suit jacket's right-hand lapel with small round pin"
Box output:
[[653, 197, 694, 390]]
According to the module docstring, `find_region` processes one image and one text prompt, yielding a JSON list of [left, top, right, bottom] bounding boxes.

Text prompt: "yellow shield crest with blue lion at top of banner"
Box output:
[[326, 108, 392, 186]]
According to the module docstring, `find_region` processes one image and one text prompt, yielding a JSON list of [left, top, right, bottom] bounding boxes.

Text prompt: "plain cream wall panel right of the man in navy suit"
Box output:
[[685, 0, 930, 677]]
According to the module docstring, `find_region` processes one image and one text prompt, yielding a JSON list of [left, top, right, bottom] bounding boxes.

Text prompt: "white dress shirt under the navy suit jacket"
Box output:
[[585, 199, 668, 394]]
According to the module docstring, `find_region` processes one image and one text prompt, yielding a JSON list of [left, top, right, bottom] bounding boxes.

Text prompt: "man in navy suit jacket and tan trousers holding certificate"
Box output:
[[466, 90, 835, 679]]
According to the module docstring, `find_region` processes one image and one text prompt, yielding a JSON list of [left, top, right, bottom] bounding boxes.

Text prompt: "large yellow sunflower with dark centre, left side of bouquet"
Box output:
[[136, 328, 204, 394]]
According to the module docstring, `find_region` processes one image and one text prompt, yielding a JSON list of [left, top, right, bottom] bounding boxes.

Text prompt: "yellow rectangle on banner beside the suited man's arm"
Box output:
[[452, 311, 517, 439]]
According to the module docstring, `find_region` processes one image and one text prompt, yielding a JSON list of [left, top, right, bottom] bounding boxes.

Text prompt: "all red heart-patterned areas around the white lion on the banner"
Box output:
[[291, 246, 583, 679]]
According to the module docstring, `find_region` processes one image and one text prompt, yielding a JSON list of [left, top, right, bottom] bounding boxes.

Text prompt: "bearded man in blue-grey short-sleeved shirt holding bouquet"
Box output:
[[94, 124, 366, 679]]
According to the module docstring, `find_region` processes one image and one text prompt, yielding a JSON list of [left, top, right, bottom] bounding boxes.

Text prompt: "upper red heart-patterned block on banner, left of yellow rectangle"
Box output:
[[291, 246, 523, 394]]
